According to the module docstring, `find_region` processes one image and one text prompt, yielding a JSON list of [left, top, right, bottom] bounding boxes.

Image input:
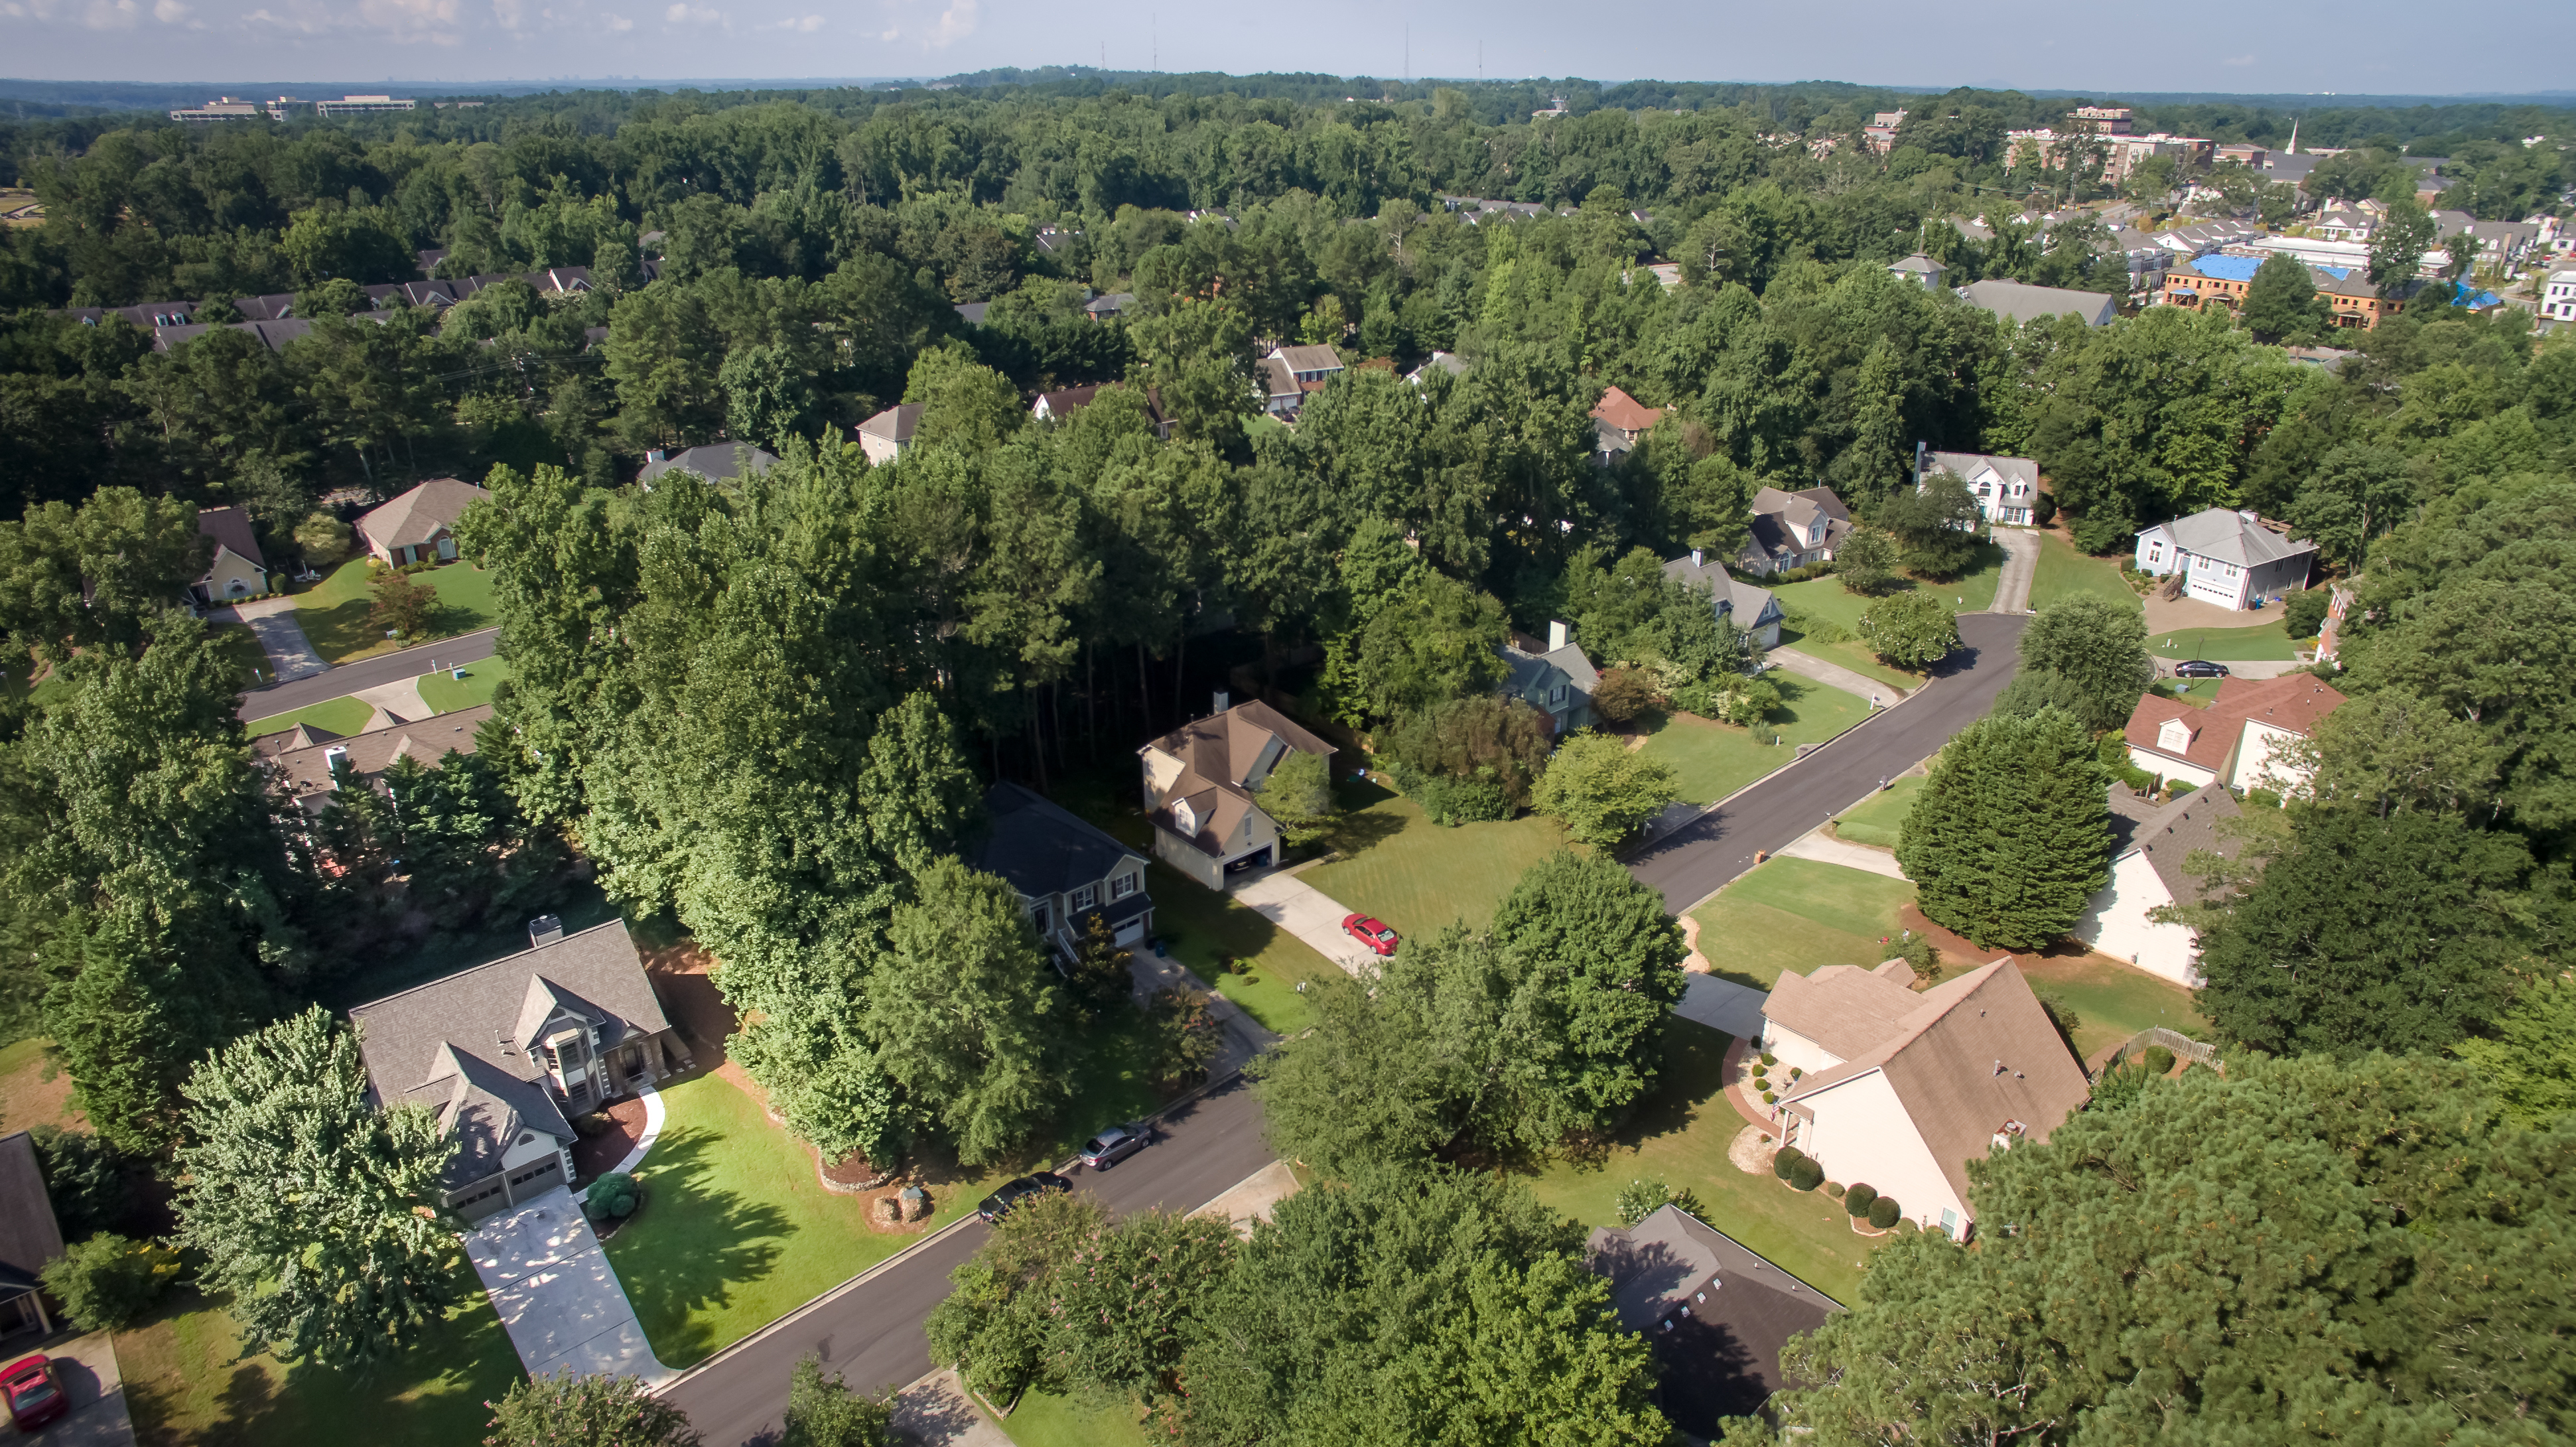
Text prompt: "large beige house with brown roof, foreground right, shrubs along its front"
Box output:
[[1762, 958, 2092, 1241]]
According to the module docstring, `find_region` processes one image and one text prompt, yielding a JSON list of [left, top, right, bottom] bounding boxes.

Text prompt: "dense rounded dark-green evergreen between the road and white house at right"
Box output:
[[1896, 711, 2110, 950]]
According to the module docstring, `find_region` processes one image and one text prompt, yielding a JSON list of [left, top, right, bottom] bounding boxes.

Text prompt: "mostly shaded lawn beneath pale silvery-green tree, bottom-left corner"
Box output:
[[116, 1267, 520, 1447]]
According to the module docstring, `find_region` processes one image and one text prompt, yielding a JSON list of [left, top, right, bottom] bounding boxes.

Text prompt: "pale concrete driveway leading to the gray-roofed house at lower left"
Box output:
[[466, 1187, 675, 1385]]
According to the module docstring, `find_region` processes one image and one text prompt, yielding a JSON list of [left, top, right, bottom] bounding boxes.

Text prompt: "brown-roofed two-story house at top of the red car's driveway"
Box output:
[[1136, 693, 1332, 888]]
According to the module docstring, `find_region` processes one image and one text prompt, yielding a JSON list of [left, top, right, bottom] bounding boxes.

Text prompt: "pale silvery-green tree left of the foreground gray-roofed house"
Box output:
[[175, 1006, 469, 1367]]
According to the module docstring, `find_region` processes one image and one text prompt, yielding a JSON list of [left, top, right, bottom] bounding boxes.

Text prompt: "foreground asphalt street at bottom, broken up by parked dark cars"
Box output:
[[659, 1079, 1272, 1447]]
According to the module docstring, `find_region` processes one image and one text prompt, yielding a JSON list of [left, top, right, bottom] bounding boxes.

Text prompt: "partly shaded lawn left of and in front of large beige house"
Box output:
[[1530, 1014, 1893, 1303]]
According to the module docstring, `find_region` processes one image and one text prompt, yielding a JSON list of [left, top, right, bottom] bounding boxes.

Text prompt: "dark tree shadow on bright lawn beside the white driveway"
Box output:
[[616, 1125, 796, 1362]]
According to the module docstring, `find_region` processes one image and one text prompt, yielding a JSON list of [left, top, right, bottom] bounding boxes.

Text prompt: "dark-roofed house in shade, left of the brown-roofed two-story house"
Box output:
[[963, 783, 1154, 955]]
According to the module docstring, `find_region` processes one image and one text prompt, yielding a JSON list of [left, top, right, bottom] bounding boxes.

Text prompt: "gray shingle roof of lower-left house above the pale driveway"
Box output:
[[348, 919, 670, 1190]]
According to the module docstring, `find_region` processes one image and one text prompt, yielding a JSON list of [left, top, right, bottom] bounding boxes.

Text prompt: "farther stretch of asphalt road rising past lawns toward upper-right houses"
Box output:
[[1628, 613, 2030, 914]]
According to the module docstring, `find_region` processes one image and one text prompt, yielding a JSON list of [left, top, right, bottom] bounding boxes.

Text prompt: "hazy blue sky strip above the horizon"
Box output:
[[0, 0, 2576, 96]]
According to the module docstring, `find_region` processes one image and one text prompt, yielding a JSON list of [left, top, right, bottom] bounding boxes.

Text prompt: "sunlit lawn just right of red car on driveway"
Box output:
[[1298, 786, 1566, 935]]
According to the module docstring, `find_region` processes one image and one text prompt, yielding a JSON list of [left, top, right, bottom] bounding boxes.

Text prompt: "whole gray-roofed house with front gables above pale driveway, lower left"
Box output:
[[348, 917, 685, 1220]]
